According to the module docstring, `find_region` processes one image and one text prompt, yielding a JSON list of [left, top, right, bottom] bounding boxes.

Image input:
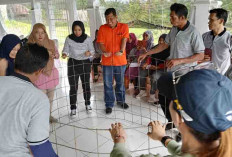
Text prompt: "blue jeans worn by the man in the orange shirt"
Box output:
[[103, 65, 126, 108]]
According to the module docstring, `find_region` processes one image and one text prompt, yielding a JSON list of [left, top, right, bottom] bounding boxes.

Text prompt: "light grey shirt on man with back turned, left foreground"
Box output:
[[0, 76, 50, 157]]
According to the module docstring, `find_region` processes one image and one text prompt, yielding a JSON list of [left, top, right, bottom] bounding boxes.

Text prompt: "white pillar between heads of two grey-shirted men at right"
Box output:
[[190, 0, 222, 34]]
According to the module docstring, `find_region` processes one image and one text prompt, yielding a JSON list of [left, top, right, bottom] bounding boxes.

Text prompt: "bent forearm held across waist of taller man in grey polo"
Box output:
[[166, 52, 204, 68]]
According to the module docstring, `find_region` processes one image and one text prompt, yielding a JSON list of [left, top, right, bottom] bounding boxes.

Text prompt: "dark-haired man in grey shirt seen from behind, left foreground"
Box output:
[[0, 44, 57, 157]]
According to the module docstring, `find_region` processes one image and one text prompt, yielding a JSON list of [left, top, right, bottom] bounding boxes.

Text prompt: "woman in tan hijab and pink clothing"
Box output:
[[28, 23, 59, 122]]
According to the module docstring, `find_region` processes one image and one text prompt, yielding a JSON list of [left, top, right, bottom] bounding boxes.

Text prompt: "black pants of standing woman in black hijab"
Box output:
[[68, 58, 91, 110]]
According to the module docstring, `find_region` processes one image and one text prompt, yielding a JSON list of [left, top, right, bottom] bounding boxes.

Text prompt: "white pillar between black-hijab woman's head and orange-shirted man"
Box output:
[[87, 0, 105, 40]]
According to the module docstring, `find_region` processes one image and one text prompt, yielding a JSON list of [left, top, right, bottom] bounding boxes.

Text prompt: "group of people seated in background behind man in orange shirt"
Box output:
[[125, 31, 170, 102]]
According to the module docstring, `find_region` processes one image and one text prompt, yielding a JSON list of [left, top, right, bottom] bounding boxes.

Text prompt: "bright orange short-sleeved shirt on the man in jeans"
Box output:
[[97, 22, 129, 66]]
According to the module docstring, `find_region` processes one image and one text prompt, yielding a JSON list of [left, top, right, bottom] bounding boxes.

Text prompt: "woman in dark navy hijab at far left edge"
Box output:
[[0, 34, 20, 76]]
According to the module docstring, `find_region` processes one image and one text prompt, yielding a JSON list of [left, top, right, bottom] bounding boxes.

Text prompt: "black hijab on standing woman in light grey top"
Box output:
[[68, 21, 87, 43]]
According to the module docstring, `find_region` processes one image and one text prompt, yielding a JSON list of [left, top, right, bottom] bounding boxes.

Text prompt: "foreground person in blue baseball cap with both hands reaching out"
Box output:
[[110, 69, 232, 157]]
